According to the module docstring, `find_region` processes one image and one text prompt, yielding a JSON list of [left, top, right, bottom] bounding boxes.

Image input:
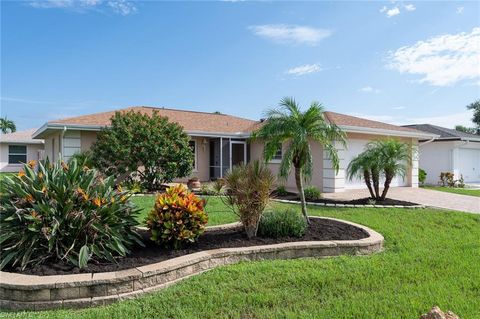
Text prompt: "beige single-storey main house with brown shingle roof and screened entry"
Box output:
[[34, 106, 435, 192]]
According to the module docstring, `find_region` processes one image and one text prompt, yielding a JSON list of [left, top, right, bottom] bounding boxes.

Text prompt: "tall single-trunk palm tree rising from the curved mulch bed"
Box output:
[[252, 98, 346, 222]]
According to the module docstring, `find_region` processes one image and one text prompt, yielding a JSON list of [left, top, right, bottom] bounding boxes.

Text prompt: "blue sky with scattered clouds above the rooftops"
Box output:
[[0, 0, 480, 129]]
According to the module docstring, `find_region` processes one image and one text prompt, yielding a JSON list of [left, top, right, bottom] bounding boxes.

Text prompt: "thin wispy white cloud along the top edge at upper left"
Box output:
[[29, 0, 137, 15]]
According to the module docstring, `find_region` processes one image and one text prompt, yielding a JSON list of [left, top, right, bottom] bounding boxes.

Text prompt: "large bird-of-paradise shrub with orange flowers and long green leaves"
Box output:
[[0, 159, 142, 269]]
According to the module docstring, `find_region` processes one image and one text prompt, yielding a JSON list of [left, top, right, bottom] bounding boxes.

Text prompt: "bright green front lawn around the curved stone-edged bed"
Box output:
[[0, 198, 480, 319]]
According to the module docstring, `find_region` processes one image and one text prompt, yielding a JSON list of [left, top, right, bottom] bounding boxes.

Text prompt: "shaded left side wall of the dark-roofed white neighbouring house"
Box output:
[[419, 141, 455, 185]]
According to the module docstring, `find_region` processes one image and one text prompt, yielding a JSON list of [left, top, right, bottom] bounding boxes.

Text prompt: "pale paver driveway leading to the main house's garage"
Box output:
[[322, 187, 480, 214]]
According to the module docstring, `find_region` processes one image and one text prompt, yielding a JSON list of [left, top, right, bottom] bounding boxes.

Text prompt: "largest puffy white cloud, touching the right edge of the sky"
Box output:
[[387, 28, 480, 86]]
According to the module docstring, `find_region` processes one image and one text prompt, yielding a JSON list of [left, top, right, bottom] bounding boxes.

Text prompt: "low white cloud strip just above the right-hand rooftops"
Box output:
[[350, 111, 473, 128]]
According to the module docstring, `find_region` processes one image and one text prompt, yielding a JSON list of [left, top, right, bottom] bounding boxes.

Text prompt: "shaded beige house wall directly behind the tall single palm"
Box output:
[[250, 142, 324, 192]]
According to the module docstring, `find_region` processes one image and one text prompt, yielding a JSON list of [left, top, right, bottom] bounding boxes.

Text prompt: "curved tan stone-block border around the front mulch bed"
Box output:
[[0, 217, 384, 311]]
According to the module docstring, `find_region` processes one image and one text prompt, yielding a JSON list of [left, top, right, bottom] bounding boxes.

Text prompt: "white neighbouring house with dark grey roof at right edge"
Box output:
[[405, 124, 480, 184]]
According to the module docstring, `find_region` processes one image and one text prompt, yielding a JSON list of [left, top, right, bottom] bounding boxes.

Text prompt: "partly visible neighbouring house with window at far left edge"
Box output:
[[0, 129, 44, 172]]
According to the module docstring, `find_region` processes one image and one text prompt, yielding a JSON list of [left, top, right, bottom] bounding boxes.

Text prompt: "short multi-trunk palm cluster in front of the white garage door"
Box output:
[[347, 138, 412, 201]]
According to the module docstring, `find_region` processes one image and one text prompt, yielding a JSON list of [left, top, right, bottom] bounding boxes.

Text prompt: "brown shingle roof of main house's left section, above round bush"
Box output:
[[49, 106, 257, 133]]
